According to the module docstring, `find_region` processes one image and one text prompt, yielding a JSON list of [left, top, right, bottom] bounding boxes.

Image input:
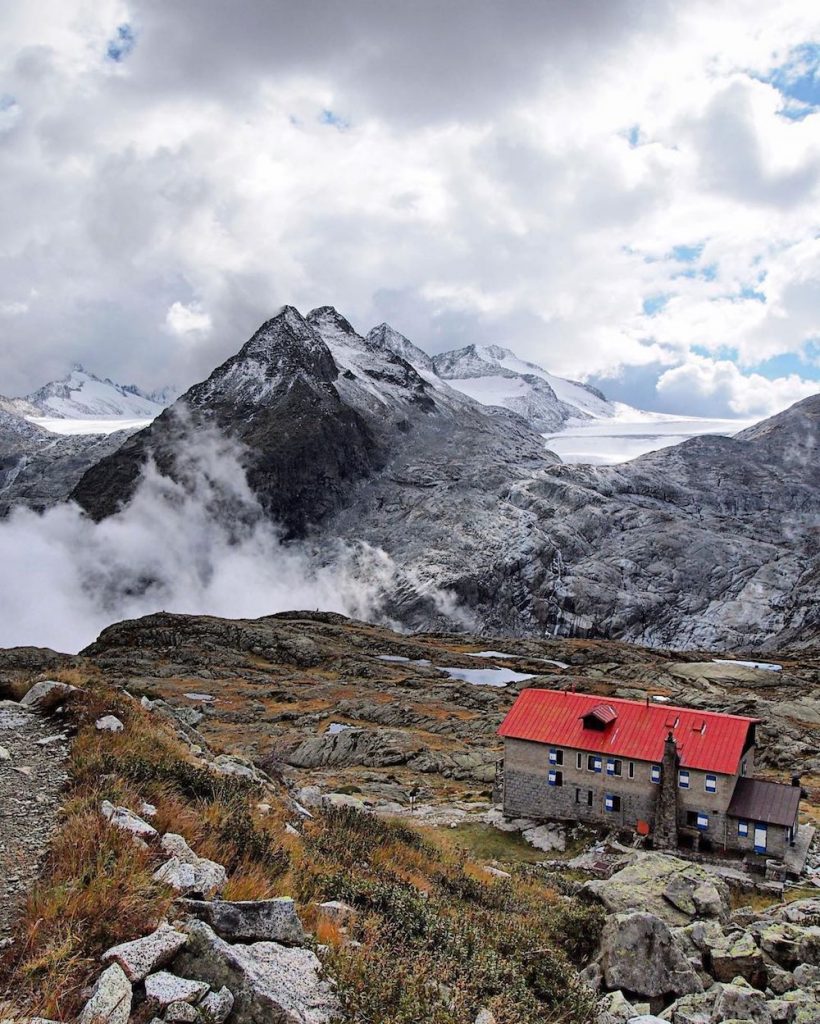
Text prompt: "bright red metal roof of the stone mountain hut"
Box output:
[[499, 687, 759, 775]]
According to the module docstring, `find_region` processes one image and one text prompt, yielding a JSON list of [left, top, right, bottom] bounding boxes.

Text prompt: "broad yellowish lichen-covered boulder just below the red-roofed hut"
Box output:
[[580, 853, 729, 925]]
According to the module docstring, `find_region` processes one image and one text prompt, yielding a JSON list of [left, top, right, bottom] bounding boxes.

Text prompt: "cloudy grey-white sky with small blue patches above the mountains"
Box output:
[[0, 0, 820, 416]]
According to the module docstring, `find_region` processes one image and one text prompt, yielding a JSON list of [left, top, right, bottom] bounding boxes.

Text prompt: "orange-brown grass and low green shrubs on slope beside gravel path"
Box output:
[[0, 680, 601, 1024]]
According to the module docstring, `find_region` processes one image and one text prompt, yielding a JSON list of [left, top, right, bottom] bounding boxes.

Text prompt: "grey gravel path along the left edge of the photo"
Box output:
[[0, 700, 68, 945]]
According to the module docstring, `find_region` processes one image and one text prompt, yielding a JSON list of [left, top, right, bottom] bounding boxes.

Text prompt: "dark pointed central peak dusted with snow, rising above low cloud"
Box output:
[[74, 306, 551, 537]]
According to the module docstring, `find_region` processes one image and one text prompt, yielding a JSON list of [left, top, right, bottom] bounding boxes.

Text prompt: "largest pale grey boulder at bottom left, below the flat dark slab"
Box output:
[[174, 921, 341, 1024]]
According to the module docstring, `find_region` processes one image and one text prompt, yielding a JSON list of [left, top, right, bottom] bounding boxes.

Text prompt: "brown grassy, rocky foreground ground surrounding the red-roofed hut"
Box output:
[[0, 612, 820, 1024]]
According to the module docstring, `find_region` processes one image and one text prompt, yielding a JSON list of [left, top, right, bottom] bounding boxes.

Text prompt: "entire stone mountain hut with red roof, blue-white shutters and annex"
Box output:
[[499, 687, 801, 859]]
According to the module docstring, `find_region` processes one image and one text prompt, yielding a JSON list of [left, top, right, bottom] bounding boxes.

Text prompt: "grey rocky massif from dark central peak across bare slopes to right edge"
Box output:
[[4, 306, 820, 650]]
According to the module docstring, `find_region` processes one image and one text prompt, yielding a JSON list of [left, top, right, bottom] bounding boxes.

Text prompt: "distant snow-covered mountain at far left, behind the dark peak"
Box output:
[[23, 365, 165, 420]]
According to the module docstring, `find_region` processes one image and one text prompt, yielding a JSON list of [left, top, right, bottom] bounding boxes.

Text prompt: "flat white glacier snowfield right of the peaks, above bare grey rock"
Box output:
[[544, 411, 756, 466]]
